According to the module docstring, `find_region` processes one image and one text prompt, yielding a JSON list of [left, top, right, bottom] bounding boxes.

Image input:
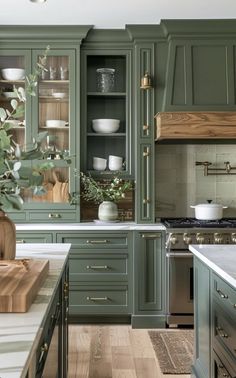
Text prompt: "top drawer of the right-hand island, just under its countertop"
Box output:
[[212, 273, 236, 317]]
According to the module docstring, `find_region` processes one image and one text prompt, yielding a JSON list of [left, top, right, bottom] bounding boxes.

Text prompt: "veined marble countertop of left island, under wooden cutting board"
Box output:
[[0, 243, 70, 378]]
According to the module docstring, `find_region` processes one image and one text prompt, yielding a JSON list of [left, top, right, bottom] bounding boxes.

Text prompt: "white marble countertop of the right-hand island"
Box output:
[[189, 244, 236, 289]]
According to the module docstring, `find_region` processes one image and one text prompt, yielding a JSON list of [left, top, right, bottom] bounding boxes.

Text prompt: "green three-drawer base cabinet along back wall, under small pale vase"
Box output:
[[57, 231, 133, 322]]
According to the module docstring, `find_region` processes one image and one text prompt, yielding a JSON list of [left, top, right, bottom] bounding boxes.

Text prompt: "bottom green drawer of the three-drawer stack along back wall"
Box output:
[[69, 285, 129, 315]]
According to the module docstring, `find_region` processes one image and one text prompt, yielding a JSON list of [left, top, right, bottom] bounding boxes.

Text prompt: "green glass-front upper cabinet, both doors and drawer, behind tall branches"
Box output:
[[0, 48, 76, 222]]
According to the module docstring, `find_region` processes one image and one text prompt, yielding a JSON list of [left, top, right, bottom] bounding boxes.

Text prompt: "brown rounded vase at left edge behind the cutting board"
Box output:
[[0, 210, 16, 260]]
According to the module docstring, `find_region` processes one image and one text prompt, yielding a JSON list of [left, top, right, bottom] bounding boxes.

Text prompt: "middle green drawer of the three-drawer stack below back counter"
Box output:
[[69, 251, 128, 282]]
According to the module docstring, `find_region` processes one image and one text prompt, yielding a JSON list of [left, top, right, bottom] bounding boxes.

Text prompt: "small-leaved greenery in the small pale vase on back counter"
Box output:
[[80, 172, 133, 204]]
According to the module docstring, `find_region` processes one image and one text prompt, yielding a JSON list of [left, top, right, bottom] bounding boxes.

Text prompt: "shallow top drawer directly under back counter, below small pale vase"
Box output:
[[57, 232, 128, 249]]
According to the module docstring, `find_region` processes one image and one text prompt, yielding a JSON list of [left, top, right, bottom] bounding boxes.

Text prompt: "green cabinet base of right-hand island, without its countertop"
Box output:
[[192, 257, 236, 378]]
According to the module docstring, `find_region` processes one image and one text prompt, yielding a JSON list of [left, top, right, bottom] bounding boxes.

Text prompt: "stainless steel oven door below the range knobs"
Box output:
[[166, 251, 193, 324]]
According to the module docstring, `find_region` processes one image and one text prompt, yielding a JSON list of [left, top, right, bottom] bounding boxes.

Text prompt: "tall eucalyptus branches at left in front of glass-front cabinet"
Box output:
[[0, 46, 53, 211]]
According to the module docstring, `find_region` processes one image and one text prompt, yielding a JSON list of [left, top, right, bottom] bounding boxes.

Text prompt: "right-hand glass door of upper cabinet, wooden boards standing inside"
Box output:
[[27, 49, 76, 219]]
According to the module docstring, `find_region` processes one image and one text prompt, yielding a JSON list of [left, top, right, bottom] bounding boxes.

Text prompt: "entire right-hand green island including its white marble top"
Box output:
[[189, 245, 236, 378]]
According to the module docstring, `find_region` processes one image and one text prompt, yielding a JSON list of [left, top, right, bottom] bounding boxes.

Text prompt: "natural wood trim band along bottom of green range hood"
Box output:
[[155, 111, 236, 141]]
